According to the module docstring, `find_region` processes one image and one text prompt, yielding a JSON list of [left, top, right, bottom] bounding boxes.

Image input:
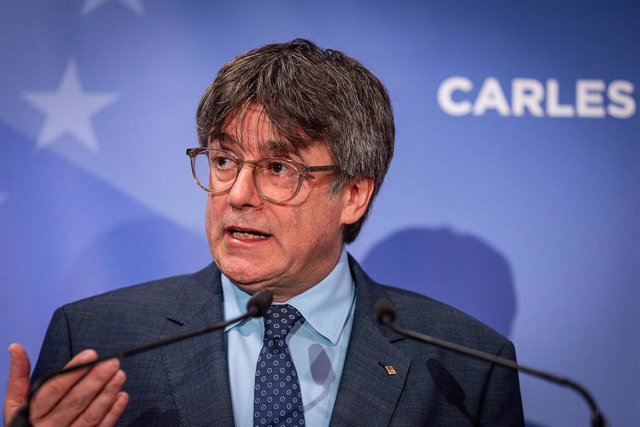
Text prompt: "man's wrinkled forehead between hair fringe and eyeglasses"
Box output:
[[209, 103, 319, 157]]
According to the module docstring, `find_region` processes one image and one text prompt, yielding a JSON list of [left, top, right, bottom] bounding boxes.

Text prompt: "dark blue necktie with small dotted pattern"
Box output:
[[253, 304, 304, 427]]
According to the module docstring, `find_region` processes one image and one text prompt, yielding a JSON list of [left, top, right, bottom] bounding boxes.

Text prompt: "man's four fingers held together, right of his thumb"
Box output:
[[31, 351, 126, 426]]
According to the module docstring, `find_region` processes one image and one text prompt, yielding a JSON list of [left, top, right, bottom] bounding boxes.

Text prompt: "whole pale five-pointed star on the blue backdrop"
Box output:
[[23, 60, 118, 152]]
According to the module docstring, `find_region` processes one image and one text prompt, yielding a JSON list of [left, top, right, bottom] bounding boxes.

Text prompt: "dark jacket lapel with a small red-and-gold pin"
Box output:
[[330, 257, 411, 426]]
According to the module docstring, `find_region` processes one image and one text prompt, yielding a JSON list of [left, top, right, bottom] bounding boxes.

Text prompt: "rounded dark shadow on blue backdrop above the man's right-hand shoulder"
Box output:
[[364, 227, 516, 336]]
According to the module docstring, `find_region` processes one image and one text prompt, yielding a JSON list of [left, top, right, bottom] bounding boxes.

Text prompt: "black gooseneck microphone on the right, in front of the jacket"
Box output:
[[374, 298, 608, 427]]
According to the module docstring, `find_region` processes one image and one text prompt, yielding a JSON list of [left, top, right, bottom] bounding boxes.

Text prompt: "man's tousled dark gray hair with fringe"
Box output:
[[196, 39, 395, 243]]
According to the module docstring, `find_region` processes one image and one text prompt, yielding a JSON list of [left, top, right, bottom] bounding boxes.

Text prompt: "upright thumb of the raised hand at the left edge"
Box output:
[[4, 344, 30, 425]]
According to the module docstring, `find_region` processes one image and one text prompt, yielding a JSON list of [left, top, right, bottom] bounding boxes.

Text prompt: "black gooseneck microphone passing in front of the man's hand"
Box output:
[[9, 290, 273, 427]]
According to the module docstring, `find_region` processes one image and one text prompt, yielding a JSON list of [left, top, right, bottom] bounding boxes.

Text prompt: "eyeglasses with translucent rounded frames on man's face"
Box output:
[[187, 148, 339, 203]]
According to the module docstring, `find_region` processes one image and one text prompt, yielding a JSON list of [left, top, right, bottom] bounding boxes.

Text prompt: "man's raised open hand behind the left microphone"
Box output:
[[4, 344, 129, 427]]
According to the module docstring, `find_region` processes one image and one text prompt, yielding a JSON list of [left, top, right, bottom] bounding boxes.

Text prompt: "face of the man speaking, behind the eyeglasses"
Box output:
[[206, 105, 368, 301]]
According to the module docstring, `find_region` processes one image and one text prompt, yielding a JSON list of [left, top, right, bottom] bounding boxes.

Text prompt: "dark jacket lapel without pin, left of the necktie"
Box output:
[[162, 264, 233, 426]]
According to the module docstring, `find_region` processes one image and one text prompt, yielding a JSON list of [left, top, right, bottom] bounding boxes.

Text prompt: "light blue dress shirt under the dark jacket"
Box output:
[[222, 249, 355, 427]]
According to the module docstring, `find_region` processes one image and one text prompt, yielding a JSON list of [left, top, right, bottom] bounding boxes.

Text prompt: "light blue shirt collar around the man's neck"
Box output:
[[221, 248, 355, 344]]
